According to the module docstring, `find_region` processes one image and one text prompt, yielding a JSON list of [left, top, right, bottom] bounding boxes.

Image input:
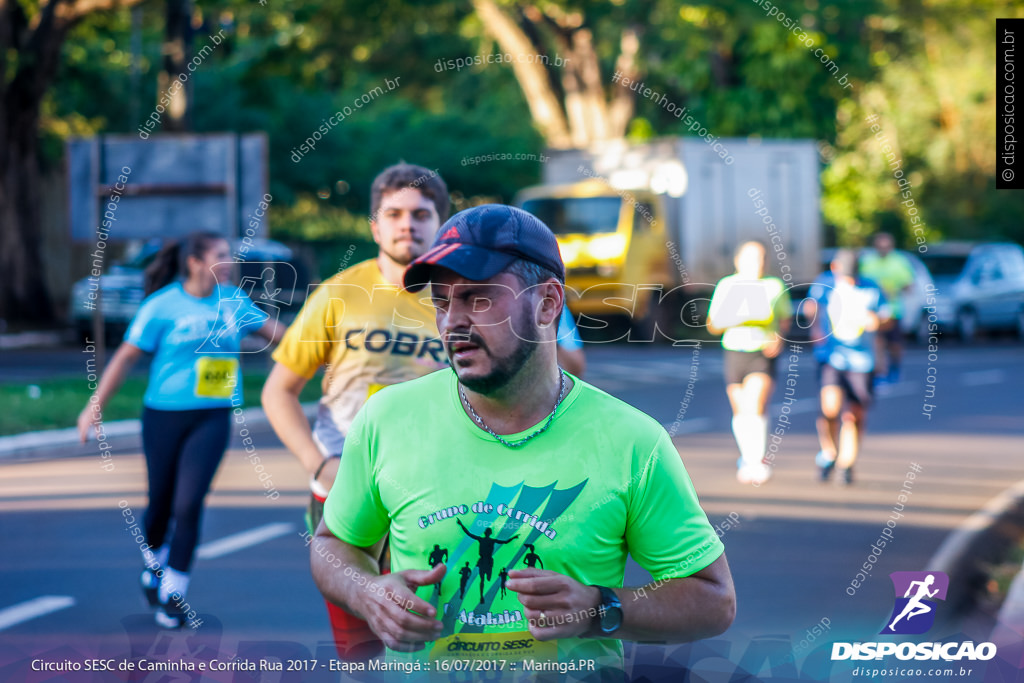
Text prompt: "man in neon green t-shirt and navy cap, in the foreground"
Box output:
[[311, 205, 735, 671]]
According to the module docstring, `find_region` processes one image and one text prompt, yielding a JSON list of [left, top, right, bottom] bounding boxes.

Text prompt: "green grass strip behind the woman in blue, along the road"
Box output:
[[0, 371, 321, 436]]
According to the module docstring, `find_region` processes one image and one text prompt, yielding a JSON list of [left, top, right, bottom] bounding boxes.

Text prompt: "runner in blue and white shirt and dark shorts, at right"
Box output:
[[806, 249, 889, 485]]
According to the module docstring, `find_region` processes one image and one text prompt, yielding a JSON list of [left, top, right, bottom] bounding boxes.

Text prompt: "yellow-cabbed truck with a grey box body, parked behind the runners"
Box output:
[[515, 138, 821, 341]]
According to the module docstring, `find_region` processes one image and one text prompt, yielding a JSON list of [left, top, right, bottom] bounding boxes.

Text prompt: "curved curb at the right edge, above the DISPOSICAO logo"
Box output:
[[926, 481, 1024, 621]]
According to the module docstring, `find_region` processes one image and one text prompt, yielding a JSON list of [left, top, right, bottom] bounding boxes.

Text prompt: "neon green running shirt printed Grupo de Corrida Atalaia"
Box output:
[[324, 370, 724, 666]]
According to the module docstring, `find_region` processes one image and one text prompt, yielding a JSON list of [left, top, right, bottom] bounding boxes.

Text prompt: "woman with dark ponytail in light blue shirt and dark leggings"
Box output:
[[78, 232, 284, 629]]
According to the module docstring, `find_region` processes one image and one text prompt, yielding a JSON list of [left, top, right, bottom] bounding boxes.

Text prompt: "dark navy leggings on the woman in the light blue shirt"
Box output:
[[142, 408, 231, 571]]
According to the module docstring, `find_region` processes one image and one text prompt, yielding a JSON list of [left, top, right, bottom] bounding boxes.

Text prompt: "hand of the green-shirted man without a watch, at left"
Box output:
[[352, 564, 447, 652]]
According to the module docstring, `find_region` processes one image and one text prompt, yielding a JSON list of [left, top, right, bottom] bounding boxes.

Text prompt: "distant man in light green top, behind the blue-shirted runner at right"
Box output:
[[860, 232, 914, 384]]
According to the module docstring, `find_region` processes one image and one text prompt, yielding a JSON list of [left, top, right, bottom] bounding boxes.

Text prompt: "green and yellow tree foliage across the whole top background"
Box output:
[[44, 0, 1024, 282]]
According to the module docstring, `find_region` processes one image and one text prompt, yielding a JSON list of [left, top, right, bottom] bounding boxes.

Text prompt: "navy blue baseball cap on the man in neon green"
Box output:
[[402, 204, 565, 292]]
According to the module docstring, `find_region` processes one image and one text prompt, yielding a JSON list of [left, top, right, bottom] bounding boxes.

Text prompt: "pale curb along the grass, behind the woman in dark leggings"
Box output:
[[0, 401, 319, 463]]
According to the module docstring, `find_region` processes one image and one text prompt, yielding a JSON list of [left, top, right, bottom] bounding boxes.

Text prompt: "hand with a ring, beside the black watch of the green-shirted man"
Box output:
[[505, 567, 601, 640]]
